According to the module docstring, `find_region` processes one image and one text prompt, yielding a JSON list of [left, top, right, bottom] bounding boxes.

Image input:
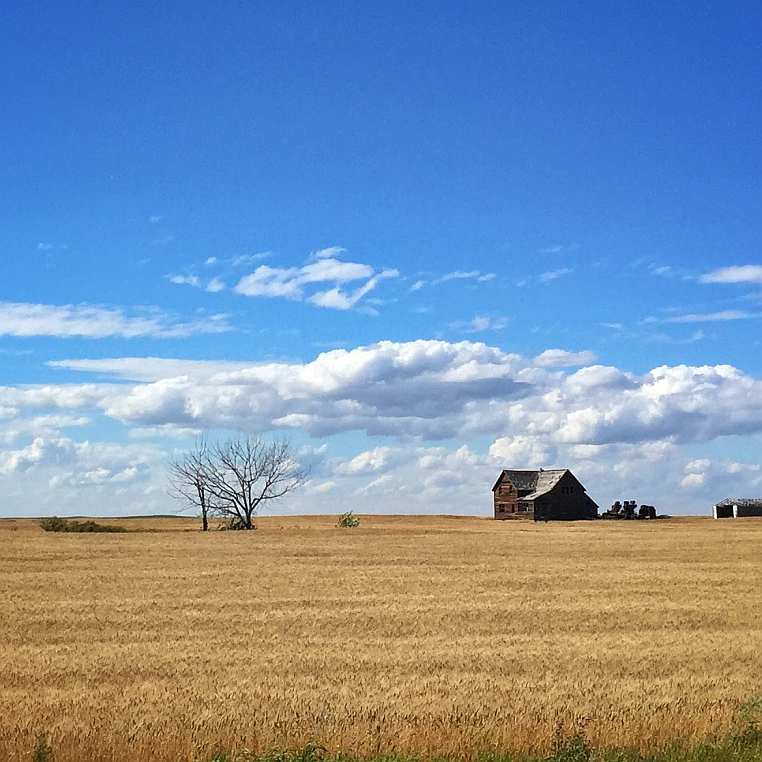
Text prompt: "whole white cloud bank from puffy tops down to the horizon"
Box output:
[[7, 341, 762, 513]]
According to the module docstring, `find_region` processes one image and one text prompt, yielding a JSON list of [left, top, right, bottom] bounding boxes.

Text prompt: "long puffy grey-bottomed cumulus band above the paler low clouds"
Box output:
[[35, 340, 762, 452]]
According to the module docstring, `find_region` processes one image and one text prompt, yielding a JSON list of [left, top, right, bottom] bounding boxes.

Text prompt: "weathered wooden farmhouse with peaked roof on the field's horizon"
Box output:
[[492, 468, 598, 521]]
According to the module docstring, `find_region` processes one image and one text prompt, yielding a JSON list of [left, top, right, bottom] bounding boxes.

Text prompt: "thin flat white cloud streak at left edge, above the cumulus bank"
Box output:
[[0, 302, 230, 339]]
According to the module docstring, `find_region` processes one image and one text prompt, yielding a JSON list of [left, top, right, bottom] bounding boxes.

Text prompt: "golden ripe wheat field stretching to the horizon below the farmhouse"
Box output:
[[0, 517, 762, 762]]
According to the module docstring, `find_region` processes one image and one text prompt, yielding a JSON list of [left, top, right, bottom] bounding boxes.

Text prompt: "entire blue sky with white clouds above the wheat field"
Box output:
[[0, 3, 762, 513]]
